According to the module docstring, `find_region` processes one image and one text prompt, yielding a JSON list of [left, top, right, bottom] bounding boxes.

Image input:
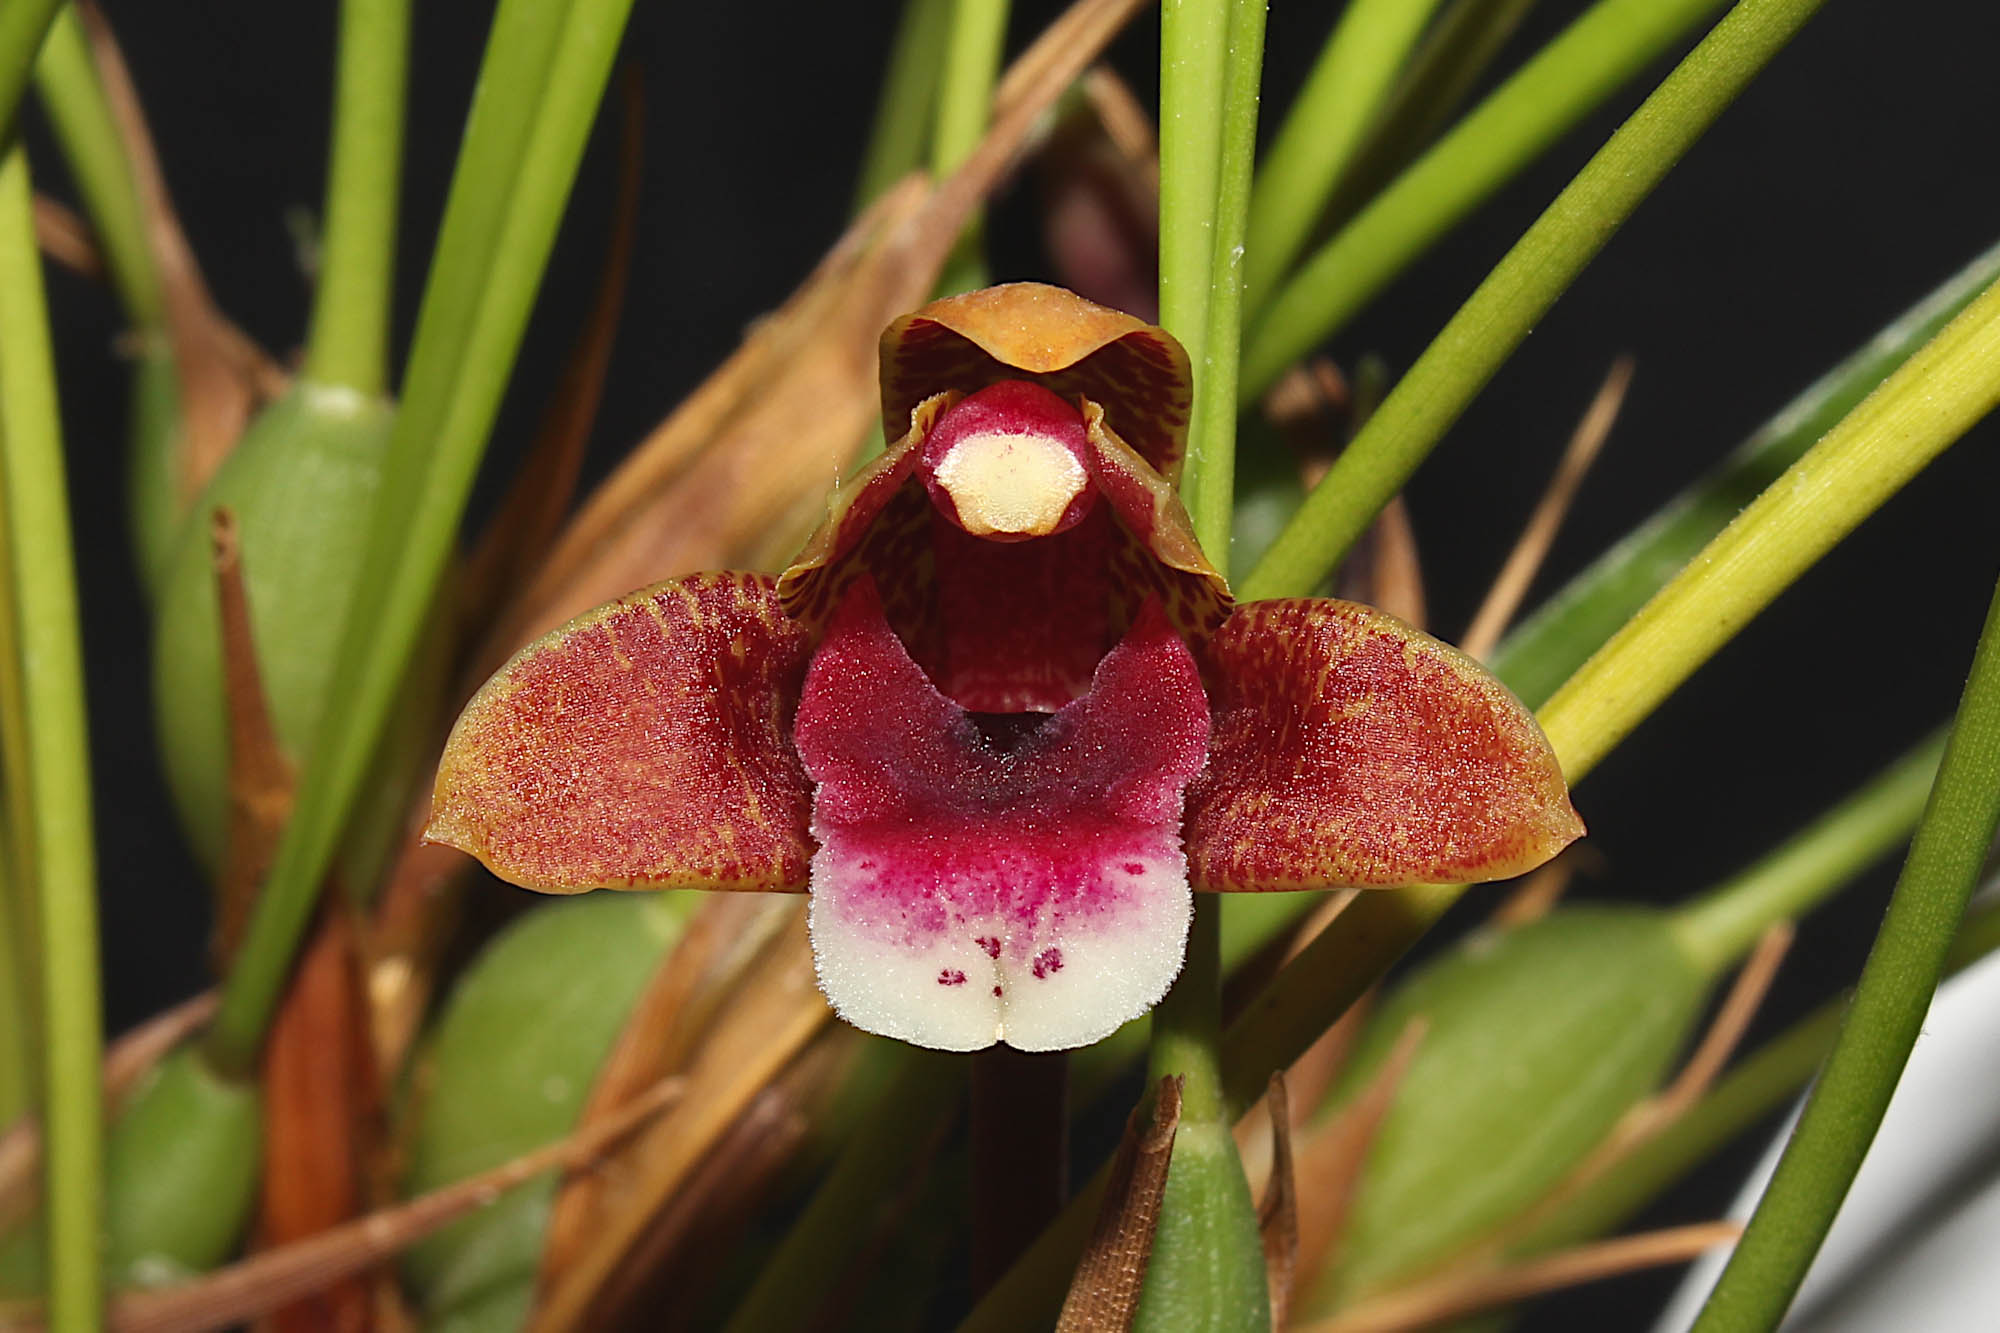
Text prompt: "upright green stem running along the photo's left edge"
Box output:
[[0, 142, 104, 1333]]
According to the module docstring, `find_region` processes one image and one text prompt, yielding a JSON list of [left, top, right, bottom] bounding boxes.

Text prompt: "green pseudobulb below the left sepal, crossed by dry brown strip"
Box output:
[[404, 893, 696, 1329]]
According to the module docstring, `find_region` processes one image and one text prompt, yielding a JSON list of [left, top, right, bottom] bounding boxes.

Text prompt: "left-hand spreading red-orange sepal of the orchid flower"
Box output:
[[424, 574, 812, 893]]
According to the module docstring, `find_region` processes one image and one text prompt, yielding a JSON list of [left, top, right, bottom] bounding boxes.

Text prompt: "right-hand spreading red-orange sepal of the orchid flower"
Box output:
[[1188, 598, 1584, 891]]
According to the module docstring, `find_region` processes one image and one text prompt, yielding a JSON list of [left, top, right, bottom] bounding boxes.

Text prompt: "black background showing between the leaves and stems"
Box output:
[[32, 0, 2000, 1327]]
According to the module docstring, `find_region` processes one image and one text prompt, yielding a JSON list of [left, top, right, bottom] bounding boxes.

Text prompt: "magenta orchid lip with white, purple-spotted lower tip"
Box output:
[[798, 580, 1208, 1051]]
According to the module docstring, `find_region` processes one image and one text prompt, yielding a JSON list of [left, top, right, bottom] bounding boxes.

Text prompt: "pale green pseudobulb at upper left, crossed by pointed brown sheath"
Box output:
[[154, 382, 394, 869]]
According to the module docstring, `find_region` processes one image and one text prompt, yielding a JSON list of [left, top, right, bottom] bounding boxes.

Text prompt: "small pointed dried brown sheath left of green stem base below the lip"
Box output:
[[1056, 1075, 1182, 1333]]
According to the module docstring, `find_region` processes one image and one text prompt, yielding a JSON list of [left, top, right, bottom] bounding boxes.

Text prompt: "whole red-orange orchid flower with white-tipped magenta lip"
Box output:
[[428, 284, 1582, 1051]]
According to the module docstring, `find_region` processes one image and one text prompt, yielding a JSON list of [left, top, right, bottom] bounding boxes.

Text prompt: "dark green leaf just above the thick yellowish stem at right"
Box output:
[[1488, 246, 2000, 709]]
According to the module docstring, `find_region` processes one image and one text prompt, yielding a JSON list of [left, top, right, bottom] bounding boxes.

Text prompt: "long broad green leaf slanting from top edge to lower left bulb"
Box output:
[[208, 0, 630, 1073]]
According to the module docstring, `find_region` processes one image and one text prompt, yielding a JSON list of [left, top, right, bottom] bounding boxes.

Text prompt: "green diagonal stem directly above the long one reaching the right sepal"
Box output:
[[1242, 0, 1722, 398]]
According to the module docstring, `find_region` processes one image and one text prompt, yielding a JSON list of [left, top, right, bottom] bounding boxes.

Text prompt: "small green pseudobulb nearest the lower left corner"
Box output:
[[0, 1047, 262, 1297]]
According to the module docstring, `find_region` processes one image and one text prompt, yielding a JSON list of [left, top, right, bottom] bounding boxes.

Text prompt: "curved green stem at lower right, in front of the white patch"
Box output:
[[1694, 568, 2000, 1333]]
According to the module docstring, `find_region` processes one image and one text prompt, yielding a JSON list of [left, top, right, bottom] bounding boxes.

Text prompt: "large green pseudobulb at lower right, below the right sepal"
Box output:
[[1300, 907, 1708, 1311]]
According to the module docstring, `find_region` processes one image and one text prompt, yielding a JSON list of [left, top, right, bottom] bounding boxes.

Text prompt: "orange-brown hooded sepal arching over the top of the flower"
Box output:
[[882, 282, 1194, 478]]
